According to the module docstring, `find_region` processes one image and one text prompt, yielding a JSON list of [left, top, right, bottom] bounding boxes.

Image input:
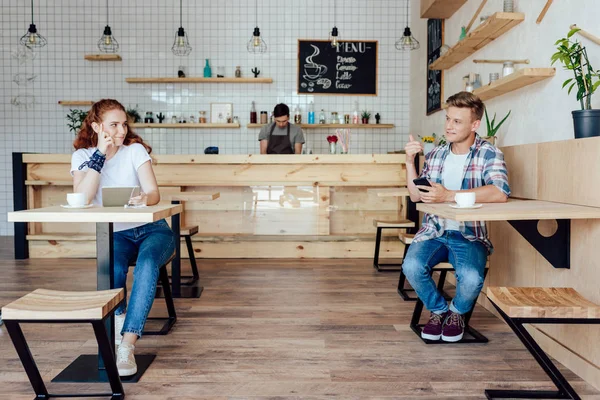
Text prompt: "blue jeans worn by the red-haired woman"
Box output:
[[114, 219, 175, 337]]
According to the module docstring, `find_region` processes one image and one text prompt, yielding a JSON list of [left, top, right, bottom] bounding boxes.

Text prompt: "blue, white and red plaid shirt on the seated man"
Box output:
[[413, 134, 510, 254]]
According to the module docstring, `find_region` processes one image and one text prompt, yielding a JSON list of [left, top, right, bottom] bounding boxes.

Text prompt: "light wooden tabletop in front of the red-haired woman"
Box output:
[[8, 204, 183, 222]]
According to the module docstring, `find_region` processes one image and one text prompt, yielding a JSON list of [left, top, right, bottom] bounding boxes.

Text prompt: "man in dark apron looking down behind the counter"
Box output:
[[258, 104, 304, 154]]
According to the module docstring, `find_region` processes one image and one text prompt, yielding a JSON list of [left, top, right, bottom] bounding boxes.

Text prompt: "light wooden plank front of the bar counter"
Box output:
[[13, 153, 416, 258]]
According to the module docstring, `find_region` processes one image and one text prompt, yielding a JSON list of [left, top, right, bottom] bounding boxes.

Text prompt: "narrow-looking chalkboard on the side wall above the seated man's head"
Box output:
[[426, 19, 444, 115]]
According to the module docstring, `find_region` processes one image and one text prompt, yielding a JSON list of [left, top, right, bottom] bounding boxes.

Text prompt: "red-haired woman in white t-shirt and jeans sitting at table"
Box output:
[[71, 100, 175, 376]]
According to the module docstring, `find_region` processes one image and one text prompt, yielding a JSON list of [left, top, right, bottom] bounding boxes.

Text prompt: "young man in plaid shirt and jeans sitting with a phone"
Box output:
[[402, 92, 510, 342]]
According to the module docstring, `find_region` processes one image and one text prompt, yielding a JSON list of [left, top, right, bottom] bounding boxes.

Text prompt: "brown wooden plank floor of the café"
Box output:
[[0, 236, 600, 400]]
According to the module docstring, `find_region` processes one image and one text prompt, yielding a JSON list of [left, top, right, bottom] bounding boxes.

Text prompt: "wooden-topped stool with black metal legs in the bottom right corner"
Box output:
[[485, 287, 600, 399]]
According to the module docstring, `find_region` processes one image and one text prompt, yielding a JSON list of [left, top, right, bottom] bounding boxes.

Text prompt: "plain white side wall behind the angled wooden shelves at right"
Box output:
[[410, 0, 600, 146]]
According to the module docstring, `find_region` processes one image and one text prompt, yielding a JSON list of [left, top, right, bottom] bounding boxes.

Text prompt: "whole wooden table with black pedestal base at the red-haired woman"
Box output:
[[8, 205, 183, 382]]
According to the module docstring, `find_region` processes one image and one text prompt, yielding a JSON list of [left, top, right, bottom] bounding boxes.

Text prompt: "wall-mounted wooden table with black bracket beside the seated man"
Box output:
[[417, 199, 600, 268]]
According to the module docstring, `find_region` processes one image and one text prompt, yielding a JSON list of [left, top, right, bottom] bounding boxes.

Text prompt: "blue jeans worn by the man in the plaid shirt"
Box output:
[[402, 231, 488, 314]]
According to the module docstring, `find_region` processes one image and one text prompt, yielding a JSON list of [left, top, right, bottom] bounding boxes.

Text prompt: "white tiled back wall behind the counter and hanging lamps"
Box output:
[[0, 0, 412, 235]]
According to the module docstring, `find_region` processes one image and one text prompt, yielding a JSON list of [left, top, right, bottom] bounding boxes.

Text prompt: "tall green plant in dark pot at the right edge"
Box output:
[[551, 28, 600, 139]]
